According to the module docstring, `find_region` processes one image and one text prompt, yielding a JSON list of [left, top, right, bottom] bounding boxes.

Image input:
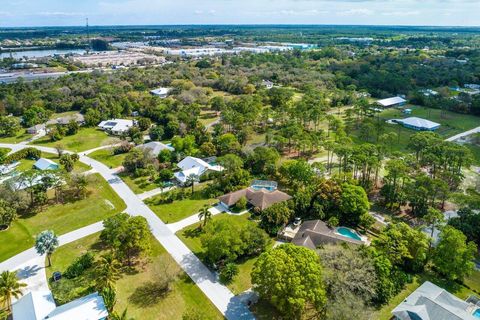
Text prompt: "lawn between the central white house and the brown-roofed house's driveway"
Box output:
[[145, 191, 218, 223]]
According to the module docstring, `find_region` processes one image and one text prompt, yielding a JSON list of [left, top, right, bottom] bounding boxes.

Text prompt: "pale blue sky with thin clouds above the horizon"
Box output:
[[0, 0, 480, 27]]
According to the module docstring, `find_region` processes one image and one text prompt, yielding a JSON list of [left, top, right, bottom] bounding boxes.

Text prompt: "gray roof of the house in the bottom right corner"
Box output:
[[392, 281, 476, 320]]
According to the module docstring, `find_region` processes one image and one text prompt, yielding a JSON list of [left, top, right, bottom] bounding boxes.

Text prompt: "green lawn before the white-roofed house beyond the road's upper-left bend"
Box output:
[[33, 128, 118, 152]]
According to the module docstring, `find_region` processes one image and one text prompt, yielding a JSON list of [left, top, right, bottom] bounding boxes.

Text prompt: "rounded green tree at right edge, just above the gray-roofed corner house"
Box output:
[[432, 226, 477, 280]]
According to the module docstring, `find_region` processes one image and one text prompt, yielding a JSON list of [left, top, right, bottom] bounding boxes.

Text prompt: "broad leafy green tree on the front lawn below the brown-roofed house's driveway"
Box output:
[[201, 220, 269, 265]]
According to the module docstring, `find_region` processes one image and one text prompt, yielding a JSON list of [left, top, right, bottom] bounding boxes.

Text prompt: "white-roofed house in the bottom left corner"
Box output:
[[12, 291, 108, 320]]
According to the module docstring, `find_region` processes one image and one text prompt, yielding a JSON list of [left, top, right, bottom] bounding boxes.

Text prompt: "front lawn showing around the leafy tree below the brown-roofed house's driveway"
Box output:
[[177, 213, 268, 294]]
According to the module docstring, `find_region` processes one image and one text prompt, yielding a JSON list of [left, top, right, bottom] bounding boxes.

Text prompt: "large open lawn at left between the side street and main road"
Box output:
[[0, 174, 126, 261]]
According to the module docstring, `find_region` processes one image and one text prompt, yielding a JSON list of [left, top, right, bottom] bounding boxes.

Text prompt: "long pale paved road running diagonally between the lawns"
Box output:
[[0, 144, 255, 320]]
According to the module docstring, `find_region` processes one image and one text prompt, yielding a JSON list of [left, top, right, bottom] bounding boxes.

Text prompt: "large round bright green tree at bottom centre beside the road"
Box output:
[[252, 244, 327, 319]]
